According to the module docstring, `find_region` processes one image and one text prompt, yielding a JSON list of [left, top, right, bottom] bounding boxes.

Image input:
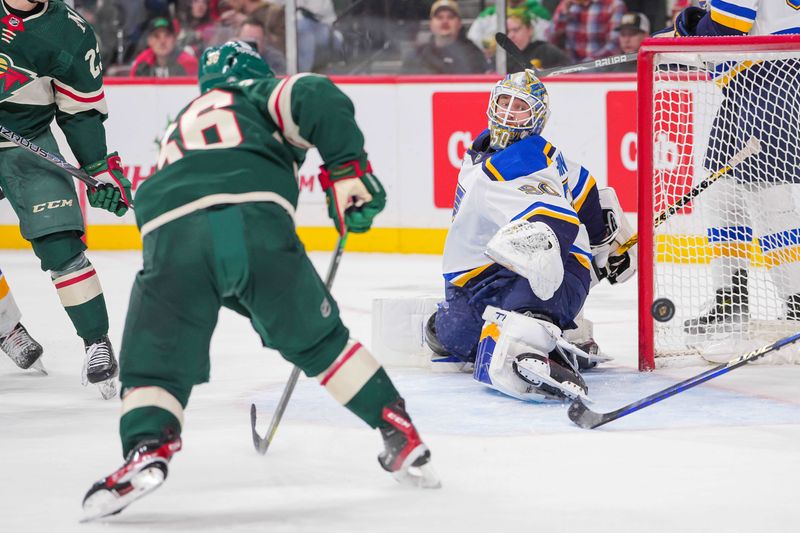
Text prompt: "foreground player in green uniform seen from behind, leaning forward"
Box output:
[[83, 41, 439, 520]]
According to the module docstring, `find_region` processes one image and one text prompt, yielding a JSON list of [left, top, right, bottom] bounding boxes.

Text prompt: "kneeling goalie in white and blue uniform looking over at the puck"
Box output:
[[425, 70, 636, 401]]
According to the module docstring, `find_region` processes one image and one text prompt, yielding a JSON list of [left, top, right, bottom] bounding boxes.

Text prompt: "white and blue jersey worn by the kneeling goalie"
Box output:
[[443, 130, 605, 290]]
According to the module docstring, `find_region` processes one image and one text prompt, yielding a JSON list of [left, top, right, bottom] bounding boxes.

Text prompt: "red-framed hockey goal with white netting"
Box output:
[[637, 35, 800, 370]]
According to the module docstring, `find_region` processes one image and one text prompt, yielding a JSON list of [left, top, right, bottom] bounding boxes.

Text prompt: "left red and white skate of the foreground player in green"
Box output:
[[82, 437, 181, 522]]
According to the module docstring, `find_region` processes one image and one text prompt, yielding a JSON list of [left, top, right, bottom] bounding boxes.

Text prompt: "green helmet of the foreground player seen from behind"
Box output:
[[197, 41, 275, 93]]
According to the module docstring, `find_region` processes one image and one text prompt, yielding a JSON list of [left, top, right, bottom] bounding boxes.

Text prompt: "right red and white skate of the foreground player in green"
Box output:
[[378, 398, 442, 489]]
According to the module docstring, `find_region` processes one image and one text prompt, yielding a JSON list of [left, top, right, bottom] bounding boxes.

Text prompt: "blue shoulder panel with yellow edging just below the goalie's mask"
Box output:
[[482, 135, 557, 181]]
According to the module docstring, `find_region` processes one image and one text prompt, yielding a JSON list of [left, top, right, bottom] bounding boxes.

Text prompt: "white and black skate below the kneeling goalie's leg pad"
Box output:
[[511, 353, 591, 402]]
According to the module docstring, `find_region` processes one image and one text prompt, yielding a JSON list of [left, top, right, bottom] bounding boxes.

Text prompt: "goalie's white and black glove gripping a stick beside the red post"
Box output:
[[592, 187, 638, 284]]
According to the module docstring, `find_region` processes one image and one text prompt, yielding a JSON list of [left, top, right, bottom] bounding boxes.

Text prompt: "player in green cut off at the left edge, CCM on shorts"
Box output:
[[0, 0, 131, 398]]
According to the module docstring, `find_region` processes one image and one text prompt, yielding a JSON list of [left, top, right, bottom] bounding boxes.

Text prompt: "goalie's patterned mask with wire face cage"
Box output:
[[486, 69, 550, 150]]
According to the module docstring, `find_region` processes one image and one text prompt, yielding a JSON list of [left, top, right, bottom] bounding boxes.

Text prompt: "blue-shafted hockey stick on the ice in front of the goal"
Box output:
[[567, 333, 800, 429]]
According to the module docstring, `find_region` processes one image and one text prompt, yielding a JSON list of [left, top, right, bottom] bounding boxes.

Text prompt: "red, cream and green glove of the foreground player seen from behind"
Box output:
[[319, 159, 386, 235]]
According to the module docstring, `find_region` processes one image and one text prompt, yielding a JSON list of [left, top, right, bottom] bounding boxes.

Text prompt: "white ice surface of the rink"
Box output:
[[0, 251, 800, 533]]
